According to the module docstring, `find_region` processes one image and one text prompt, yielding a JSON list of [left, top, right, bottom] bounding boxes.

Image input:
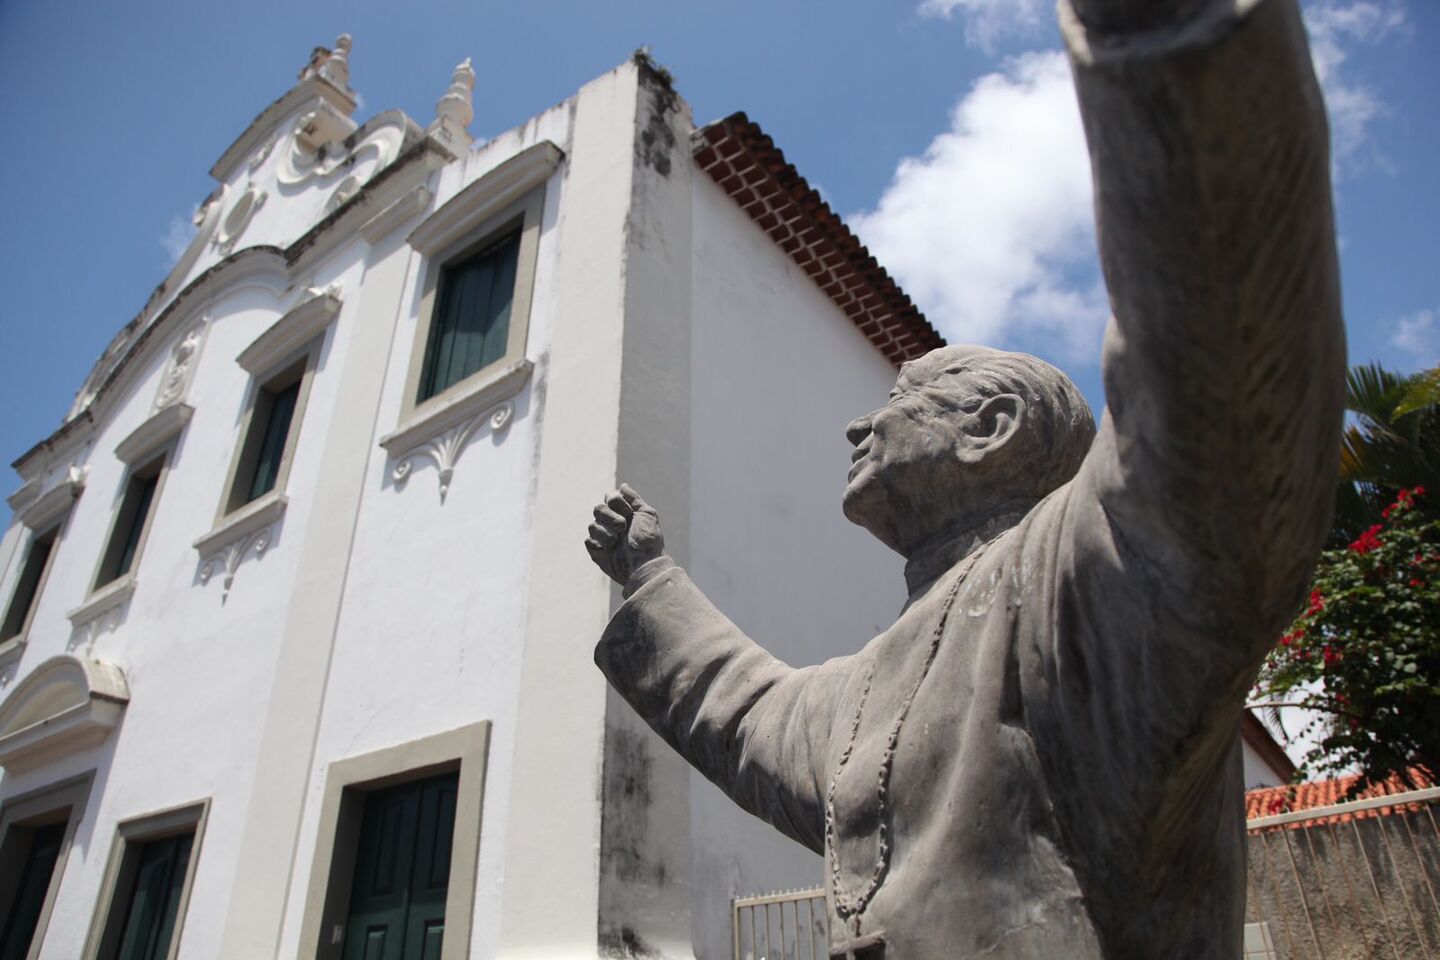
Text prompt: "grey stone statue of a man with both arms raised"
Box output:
[[586, 0, 1345, 960]]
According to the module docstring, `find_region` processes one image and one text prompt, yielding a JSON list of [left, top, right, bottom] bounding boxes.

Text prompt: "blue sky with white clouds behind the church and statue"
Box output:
[[0, 0, 1440, 526]]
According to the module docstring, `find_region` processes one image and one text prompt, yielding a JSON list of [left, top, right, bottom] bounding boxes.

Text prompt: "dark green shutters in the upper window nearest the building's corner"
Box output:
[[418, 232, 520, 402]]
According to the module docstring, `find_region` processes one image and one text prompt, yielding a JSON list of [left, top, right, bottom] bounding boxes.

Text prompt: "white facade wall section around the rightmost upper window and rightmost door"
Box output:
[[270, 92, 572, 956]]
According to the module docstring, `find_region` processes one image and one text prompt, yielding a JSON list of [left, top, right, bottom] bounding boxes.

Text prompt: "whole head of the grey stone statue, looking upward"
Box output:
[[844, 345, 1094, 557]]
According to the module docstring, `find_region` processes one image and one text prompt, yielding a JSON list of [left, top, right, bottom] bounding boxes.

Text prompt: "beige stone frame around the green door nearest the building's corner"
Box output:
[[298, 720, 490, 960]]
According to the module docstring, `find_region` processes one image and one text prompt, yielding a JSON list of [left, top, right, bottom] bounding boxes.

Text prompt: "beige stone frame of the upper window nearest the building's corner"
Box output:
[[400, 181, 544, 430]]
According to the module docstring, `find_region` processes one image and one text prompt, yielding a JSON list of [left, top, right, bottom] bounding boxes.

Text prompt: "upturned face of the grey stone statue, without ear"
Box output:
[[842, 351, 968, 554]]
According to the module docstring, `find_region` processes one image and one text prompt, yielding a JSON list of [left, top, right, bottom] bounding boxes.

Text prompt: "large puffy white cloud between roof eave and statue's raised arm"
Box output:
[[848, 52, 1109, 361]]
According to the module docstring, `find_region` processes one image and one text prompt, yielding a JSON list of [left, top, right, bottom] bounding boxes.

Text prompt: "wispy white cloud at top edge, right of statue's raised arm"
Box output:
[[1305, 0, 1408, 174]]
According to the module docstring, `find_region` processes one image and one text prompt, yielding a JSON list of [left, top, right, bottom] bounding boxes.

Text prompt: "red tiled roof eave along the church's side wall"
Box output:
[[691, 112, 945, 366]]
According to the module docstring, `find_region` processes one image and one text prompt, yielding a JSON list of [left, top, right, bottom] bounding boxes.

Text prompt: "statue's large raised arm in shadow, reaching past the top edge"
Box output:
[[1061, 0, 1345, 665]]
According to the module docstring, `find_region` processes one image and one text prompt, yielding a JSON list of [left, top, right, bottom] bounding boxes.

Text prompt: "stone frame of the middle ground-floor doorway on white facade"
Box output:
[[81, 797, 210, 960]]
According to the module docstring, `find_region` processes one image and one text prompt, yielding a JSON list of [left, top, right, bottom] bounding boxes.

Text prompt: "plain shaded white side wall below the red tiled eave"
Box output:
[[690, 174, 904, 960]]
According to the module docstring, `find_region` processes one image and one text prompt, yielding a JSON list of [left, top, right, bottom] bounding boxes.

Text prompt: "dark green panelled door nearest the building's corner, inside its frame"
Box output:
[[343, 773, 459, 960]]
